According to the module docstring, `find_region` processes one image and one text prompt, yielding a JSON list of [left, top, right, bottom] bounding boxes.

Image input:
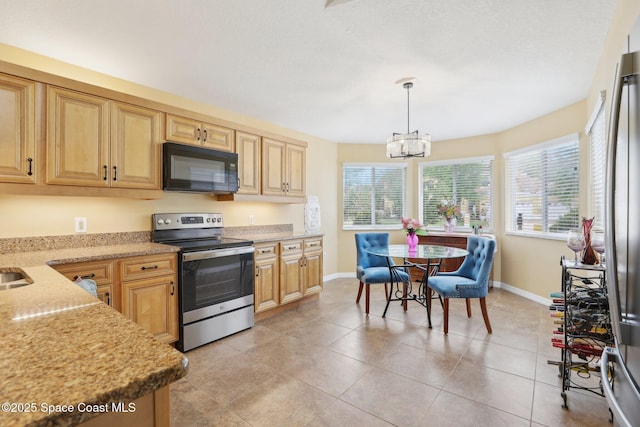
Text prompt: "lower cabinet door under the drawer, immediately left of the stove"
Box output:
[[122, 276, 178, 343]]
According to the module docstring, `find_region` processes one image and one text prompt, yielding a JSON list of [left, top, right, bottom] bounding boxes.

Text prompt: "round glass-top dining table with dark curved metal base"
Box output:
[[366, 244, 469, 328]]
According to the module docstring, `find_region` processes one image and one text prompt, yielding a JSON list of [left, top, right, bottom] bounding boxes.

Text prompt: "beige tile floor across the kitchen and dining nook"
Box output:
[[171, 279, 610, 427]]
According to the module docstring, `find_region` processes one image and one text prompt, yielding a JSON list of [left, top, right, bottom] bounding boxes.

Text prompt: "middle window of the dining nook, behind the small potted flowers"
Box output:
[[419, 156, 494, 230]]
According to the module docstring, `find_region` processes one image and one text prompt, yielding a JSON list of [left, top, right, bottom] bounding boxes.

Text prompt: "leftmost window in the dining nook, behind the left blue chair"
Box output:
[[342, 163, 406, 229]]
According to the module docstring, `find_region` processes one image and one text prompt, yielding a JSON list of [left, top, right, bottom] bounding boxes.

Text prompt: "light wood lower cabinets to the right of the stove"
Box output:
[[254, 237, 323, 313]]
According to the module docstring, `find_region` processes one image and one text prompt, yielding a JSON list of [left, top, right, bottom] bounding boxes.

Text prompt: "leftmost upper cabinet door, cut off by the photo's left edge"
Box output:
[[0, 74, 36, 183]]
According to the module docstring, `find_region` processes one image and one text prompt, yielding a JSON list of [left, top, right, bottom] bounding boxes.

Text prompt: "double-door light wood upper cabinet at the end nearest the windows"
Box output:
[[262, 138, 306, 197]]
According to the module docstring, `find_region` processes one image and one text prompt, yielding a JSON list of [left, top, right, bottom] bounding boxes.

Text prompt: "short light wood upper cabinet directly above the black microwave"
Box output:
[[166, 114, 234, 152]]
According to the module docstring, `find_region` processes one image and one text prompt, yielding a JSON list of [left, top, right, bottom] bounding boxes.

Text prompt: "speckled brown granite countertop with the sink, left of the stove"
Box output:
[[0, 243, 188, 426]]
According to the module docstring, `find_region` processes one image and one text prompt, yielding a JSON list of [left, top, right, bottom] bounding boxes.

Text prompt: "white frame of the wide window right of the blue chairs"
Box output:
[[503, 132, 580, 240]]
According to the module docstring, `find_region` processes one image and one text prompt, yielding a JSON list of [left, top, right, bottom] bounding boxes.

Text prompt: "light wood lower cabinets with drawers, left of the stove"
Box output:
[[53, 253, 178, 343]]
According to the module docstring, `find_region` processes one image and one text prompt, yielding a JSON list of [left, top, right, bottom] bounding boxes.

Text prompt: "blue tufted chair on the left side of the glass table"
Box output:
[[356, 233, 409, 314]]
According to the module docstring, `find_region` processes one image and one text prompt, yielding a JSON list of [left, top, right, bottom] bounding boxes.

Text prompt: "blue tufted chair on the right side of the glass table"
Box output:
[[428, 236, 496, 334]]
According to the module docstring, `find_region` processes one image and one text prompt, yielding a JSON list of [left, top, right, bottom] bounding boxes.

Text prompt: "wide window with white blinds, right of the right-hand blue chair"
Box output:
[[505, 134, 579, 237]]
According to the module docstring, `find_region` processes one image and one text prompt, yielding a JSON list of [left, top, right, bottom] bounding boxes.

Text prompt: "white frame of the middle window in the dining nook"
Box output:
[[416, 154, 496, 233]]
